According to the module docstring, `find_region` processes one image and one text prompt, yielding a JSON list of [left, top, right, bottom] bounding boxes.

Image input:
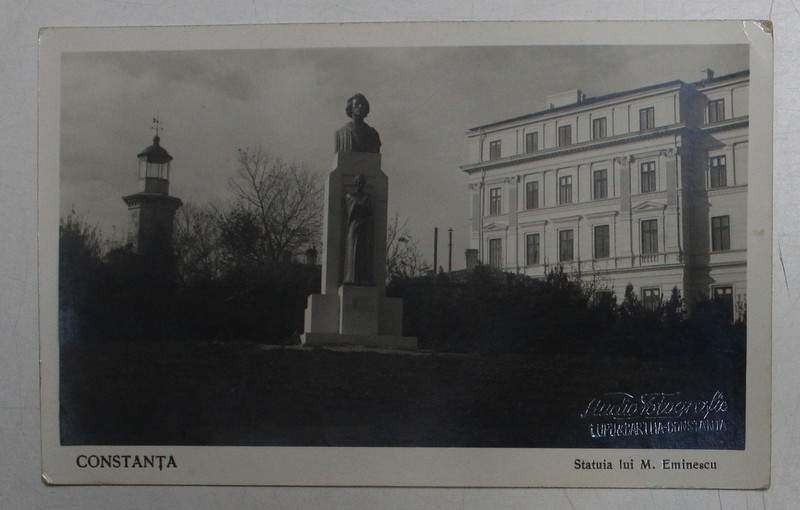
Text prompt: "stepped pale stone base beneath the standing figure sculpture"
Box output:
[[300, 284, 417, 349]]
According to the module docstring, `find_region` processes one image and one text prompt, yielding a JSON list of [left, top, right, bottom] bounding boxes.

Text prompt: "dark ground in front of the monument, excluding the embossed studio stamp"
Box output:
[[61, 342, 744, 449]]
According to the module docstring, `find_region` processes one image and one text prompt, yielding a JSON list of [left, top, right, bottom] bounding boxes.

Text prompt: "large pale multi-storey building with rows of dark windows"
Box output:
[[461, 70, 749, 320]]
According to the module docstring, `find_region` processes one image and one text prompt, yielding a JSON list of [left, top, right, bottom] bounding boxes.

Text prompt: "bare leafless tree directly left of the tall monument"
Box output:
[[227, 148, 323, 263]]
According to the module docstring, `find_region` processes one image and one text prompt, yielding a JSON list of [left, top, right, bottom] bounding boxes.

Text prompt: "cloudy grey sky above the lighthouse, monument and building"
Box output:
[[60, 45, 748, 270]]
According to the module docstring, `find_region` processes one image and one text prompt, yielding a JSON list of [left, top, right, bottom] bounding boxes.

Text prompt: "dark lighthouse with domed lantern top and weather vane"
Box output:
[[122, 124, 183, 265]]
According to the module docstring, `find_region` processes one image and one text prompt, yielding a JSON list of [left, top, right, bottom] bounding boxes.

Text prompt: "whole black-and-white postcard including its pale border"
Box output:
[[40, 22, 772, 488]]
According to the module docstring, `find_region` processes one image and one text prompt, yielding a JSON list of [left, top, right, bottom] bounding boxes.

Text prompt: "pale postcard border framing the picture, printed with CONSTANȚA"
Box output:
[[39, 21, 772, 488]]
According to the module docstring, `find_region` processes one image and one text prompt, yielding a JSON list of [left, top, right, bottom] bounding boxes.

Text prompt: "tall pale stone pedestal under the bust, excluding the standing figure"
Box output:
[[301, 152, 417, 349]]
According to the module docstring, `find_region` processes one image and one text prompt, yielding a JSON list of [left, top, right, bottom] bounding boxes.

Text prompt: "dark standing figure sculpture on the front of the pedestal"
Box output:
[[344, 175, 375, 285]]
